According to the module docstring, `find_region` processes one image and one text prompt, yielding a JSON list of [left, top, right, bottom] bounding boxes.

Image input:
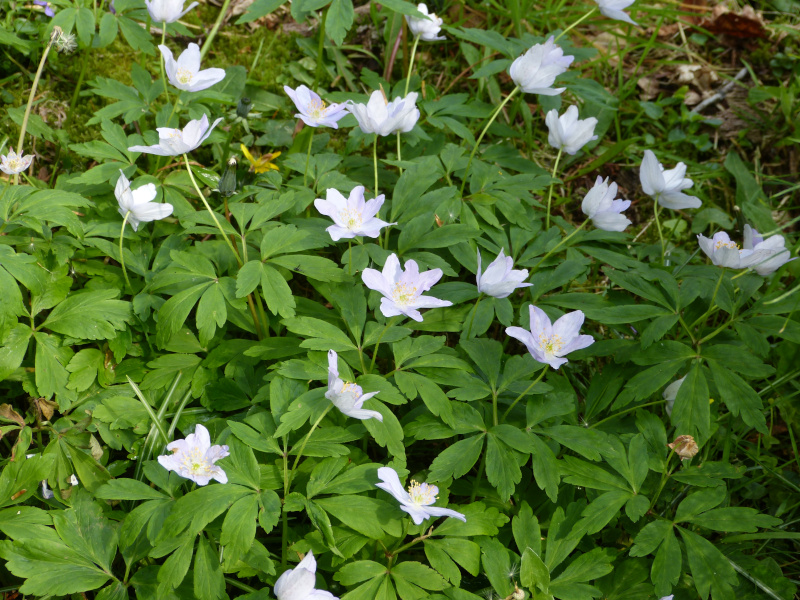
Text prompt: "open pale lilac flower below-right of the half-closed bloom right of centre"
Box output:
[[506, 305, 594, 369]]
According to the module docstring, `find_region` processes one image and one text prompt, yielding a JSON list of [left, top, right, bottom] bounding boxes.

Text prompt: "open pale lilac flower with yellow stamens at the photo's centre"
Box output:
[[361, 254, 453, 323]]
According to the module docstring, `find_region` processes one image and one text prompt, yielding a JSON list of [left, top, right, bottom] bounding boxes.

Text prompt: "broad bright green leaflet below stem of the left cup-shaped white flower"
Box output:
[[42, 290, 131, 340]]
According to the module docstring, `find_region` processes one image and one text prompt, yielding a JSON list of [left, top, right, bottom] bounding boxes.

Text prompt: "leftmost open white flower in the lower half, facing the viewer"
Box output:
[[158, 424, 230, 485]]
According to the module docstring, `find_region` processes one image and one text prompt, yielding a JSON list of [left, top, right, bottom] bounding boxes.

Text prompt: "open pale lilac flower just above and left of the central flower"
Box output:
[[314, 185, 397, 242]]
